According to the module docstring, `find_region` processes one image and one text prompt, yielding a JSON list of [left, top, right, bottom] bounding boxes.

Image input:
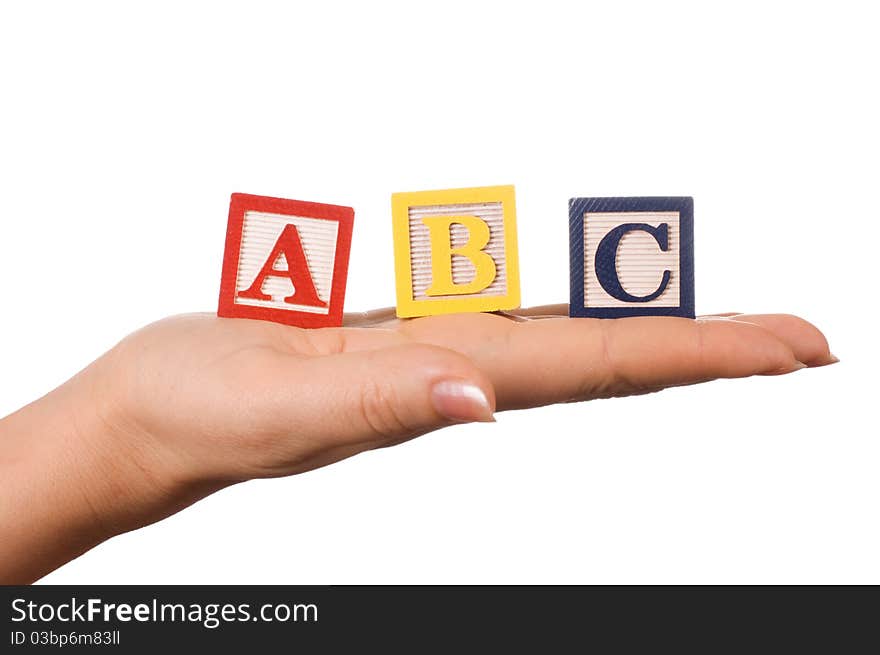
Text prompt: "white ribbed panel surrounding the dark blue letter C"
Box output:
[[584, 212, 681, 308]]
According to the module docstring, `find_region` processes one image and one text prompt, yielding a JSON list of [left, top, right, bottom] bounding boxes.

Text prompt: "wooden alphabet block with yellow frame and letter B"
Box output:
[[391, 186, 520, 317]]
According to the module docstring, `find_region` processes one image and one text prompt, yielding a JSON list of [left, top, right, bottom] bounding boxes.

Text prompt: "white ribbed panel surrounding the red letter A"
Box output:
[[235, 211, 339, 314]]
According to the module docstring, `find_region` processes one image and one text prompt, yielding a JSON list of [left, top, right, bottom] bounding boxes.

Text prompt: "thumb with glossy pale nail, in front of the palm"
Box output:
[[260, 344, 495, 470]]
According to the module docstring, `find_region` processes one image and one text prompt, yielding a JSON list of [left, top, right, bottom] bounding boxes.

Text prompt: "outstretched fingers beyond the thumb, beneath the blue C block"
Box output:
[[401, 315, 812, 409]]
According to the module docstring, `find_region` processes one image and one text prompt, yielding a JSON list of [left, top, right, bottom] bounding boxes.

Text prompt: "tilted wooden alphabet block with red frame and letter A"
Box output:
[[217, 193, 354, 328]]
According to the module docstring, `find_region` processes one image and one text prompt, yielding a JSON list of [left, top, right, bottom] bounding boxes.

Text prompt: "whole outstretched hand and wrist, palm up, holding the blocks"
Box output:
[[0, 305, 837, 584]]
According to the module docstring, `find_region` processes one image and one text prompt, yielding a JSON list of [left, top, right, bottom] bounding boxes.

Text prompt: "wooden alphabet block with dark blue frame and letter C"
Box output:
[[569, 197, 694, 318]]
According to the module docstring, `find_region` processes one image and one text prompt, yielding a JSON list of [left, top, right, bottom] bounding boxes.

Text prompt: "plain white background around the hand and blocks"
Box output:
[[0, 0, 880, 583]]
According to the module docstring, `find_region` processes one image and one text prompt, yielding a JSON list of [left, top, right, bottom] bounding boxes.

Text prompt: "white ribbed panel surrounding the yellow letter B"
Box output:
[[409, 202, 507, 300]]
